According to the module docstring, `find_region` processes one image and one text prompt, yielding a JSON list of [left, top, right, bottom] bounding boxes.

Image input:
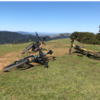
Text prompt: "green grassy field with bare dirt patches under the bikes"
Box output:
[[0, 39, 100, 100]]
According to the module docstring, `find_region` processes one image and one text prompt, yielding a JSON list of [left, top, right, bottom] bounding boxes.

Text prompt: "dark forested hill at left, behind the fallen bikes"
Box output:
[[0, 31, 36, 44]]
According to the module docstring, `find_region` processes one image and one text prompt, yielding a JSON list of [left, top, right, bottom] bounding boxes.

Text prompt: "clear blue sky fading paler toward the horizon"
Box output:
[[0, 0, 100, 33]]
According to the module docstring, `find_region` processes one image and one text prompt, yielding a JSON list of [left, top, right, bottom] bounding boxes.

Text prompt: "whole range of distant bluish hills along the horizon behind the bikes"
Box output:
[[0, 31, 71, 44]]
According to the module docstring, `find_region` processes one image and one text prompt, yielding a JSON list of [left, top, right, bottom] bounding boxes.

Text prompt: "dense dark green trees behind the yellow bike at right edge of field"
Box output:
[[70, 32, 100, 45]]
